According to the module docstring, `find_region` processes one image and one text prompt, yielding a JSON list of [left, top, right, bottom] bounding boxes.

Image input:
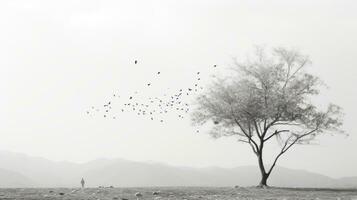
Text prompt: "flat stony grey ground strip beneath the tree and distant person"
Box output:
[[0, 187, 357, 200]]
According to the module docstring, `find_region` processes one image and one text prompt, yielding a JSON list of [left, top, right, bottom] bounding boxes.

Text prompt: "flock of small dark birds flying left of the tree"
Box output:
[[86, 60, 217, 132]]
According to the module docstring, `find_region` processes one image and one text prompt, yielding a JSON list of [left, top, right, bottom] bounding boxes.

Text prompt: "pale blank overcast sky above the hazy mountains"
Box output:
[[0, 0, 357, 177]]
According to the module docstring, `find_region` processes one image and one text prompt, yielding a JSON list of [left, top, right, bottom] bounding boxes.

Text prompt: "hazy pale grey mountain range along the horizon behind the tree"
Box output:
[[0, 151, 357, 187]]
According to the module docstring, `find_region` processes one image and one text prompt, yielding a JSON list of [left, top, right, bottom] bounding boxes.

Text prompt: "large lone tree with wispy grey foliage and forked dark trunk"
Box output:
[[192, 48, 342, 187]]
